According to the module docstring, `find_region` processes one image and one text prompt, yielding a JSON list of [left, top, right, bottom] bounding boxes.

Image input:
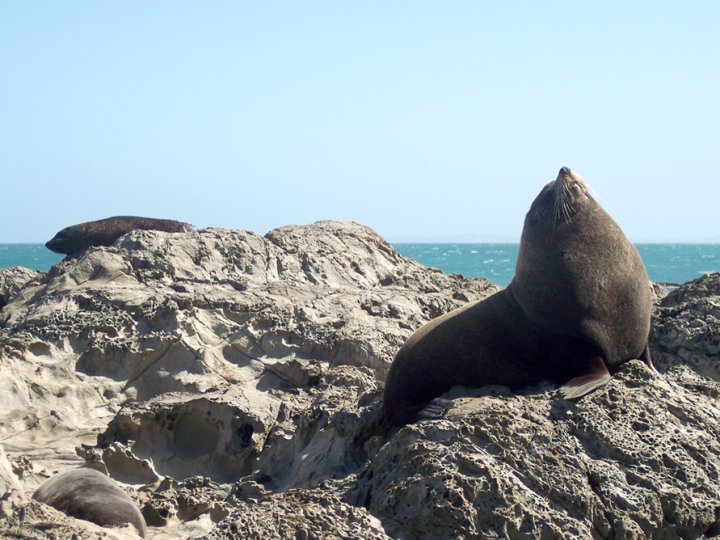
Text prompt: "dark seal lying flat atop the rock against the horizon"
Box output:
[[45, 216, 195, 255]]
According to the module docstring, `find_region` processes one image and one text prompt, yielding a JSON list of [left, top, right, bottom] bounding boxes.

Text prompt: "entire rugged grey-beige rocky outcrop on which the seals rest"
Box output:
[[0, 222, 720, 538]]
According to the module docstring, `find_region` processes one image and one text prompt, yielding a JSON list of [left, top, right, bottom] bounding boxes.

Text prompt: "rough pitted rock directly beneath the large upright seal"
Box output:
[[348, 361, 720, 538]]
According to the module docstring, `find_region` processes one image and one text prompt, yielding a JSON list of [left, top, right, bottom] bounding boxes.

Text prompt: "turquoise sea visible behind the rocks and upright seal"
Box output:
[[0, 244, 720, 286]]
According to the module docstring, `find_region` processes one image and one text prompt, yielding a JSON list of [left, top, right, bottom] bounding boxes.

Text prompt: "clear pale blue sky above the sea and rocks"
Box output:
[[0, 0, 720, 242]]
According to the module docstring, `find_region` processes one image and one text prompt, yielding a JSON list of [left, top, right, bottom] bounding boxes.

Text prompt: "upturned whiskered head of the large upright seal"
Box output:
[[527, 167, 594, 232]]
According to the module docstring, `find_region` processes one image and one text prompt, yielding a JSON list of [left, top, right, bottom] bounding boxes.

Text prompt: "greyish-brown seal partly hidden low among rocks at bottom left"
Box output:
[[33, 468, 147, 538]]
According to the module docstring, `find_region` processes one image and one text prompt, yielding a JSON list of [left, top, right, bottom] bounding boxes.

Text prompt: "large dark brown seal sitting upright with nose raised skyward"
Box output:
[[384, 167, 652, 425]]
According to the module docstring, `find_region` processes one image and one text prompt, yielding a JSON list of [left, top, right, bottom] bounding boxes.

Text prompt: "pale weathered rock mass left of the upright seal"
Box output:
[[0, 222, 497, 536]]
